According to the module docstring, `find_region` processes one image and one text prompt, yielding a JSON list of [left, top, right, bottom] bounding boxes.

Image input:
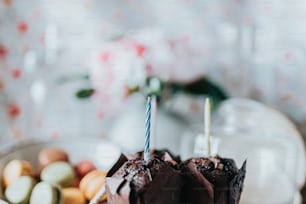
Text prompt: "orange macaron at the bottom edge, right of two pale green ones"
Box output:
[[62, 188, 86, 204]]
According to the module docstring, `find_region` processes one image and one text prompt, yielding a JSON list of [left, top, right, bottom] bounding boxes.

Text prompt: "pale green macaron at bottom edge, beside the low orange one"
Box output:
[[29, 181, 62, 204]]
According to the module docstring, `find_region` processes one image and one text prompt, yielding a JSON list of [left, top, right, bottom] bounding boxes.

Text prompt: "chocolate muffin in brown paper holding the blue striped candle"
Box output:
[[106, 156, 182, 204]]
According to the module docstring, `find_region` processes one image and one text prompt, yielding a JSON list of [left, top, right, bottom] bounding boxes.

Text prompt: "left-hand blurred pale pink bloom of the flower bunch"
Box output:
[[90, 41, 146, 114]]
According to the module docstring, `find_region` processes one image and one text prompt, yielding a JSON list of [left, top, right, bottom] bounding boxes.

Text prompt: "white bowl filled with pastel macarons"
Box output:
[[0, 138, 121, 204]]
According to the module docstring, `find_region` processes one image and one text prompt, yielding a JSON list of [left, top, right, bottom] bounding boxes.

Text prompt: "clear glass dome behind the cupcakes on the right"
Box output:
[[181, 98, 306, 204]]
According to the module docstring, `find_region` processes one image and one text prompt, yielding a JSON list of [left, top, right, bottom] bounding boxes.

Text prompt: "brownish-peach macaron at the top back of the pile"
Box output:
[[38, 147, 69, 169]]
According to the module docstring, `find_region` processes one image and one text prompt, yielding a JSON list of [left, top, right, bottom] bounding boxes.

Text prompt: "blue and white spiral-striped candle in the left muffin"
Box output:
[[143, 97, 151, 161]]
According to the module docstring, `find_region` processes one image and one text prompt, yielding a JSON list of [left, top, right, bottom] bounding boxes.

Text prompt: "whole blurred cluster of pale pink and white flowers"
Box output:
[[90, 29, 209, 115]]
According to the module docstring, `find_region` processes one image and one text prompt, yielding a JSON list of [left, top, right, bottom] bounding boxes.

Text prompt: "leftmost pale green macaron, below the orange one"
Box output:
[[4, 176, 35, 204]]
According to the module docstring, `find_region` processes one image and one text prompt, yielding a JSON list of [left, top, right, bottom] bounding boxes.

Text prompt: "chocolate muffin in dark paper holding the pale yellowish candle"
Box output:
[[181, 156, 246, 204]]
